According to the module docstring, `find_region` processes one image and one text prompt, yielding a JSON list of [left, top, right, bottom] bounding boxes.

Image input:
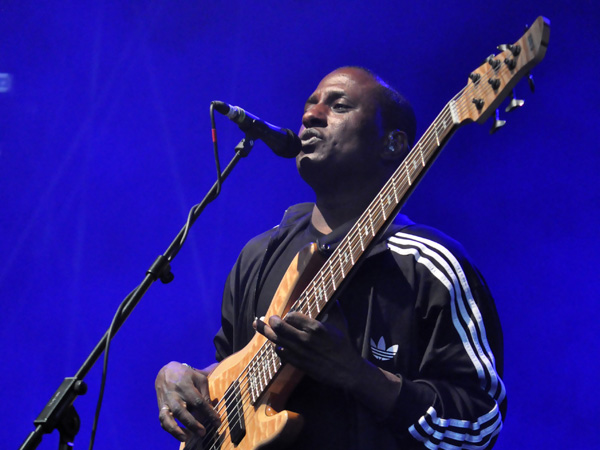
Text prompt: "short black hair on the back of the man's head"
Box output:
[[342, 66, 417, 148]]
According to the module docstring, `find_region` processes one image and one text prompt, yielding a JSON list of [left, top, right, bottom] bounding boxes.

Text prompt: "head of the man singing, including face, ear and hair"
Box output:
[[296, 67, 416, 198]]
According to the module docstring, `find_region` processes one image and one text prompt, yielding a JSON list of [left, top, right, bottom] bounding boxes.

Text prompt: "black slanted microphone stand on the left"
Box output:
[[19, 133, 254, 450]]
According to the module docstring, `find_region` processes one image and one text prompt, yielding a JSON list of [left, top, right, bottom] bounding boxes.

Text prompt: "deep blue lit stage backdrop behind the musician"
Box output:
[[0, 0, 600, 449]]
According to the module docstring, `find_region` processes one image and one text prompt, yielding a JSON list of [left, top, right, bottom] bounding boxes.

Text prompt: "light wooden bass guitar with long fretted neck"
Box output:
[[181, 17, 550, 450]]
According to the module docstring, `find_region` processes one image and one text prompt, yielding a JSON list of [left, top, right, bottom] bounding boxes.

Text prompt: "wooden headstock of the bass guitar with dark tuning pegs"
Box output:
[[454, 16, 550, 124]]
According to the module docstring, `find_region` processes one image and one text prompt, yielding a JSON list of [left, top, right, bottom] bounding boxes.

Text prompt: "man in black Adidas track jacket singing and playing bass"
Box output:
[[156, 67, 506, 449]]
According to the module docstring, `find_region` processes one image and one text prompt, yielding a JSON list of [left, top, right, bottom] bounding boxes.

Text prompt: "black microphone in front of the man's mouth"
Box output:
[[212, 101, 302, 158]]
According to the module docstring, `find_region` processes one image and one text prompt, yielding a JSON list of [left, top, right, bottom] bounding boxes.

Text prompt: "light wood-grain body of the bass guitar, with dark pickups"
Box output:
[[180, 244, 324, 450]]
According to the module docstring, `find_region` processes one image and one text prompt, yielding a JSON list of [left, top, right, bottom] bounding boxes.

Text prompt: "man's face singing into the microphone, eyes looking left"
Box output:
[[296, 68, 384, 188]]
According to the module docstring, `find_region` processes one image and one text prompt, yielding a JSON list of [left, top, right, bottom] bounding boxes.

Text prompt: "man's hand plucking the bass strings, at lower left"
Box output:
[[154, 361, 220, 442]]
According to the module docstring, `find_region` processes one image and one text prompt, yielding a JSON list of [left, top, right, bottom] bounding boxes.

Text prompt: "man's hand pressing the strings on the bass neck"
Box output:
[[254, 312, 366, 391]]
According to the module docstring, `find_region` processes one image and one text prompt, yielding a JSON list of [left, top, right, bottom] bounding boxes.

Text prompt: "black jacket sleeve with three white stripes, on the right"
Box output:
[[386, 230, 506, 449]]
